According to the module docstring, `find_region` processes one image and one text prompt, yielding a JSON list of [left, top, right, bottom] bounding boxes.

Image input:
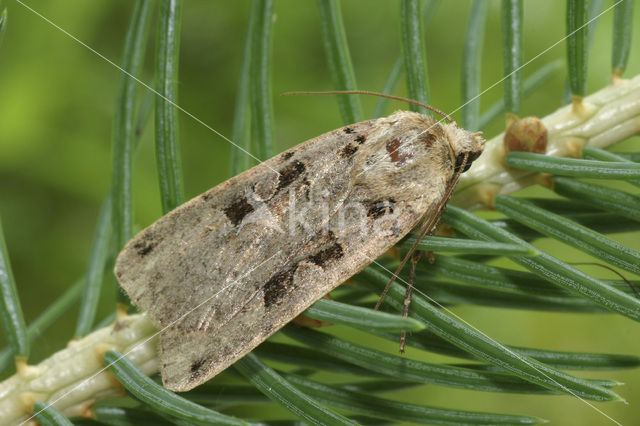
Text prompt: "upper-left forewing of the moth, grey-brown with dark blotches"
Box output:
[[115, 120, 373, 326]]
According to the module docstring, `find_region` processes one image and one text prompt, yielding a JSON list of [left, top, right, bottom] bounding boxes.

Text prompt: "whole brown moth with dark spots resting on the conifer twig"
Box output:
[[115, 111, 484, 391]]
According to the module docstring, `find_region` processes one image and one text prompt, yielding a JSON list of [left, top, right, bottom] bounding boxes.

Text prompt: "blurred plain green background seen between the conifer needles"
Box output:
[[0, 0, 640, 424]]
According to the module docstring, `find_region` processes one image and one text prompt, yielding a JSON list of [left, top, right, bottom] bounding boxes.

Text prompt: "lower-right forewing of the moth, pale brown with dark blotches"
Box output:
[[160, 194, 423, 391]]
